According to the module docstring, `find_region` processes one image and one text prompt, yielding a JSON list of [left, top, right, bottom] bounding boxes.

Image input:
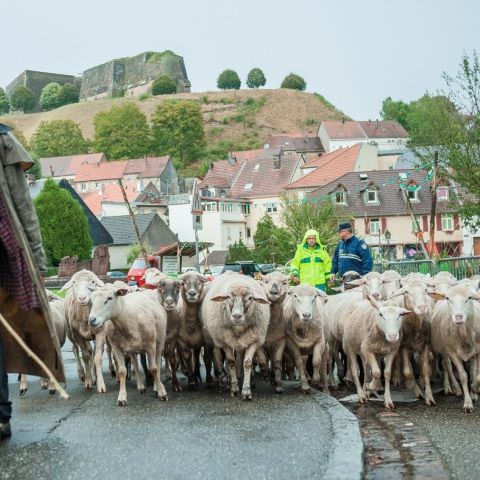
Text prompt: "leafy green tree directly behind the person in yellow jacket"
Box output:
[[282, 198, 345, 253]]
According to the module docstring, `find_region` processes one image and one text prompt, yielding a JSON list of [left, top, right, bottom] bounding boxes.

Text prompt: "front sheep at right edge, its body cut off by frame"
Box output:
[[430, 285, 480, 412]]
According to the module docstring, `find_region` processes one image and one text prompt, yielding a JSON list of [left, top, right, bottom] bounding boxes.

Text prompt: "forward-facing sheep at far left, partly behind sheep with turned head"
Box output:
[[62, 270, 106, 393]]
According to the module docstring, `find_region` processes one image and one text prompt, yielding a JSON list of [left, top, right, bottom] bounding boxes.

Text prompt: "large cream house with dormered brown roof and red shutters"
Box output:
[[307, 169, 463, 259]]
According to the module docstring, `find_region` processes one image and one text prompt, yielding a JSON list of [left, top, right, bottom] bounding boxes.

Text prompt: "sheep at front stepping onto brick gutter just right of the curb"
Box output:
[[342, 294, 410, 408]]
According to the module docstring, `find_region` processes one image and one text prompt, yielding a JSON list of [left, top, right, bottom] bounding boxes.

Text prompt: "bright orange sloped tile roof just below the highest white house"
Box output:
[[285, 143, 362, 190]]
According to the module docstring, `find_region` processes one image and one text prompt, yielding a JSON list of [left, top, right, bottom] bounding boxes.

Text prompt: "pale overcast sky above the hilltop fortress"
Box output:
[[0, 0, 480, 120]]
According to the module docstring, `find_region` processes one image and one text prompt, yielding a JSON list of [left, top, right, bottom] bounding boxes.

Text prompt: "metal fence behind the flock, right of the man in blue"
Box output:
[[373, 257, 480, 280]]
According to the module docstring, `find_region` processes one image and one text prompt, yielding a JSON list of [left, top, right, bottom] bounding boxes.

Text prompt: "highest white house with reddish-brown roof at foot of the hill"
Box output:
[[318, 119, 409, 153]]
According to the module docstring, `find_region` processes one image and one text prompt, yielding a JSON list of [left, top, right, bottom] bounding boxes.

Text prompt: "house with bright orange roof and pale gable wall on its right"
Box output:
[[285, 143, 378, 199]]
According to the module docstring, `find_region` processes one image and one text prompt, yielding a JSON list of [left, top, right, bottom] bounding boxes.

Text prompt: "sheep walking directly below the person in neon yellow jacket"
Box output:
[[283, 285, 328, 393]]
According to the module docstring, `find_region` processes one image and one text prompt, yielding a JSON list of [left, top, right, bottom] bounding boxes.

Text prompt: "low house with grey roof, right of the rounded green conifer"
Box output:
[[100, 213, 178, 270]]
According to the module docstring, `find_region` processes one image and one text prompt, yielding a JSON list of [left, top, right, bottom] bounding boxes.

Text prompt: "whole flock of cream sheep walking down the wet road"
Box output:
[[20, 269, 480, 412]]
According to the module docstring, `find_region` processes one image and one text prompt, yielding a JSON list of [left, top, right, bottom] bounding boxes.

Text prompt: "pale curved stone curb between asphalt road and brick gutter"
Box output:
[[314, 393, 364, 480]]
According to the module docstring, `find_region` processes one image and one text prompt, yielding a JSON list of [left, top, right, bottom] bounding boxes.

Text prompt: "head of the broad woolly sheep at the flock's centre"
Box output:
[[210, 284, 270, 325]]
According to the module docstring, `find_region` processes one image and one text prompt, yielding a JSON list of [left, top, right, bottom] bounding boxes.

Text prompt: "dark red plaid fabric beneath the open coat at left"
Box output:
[[0, 197, 40, 310]]
